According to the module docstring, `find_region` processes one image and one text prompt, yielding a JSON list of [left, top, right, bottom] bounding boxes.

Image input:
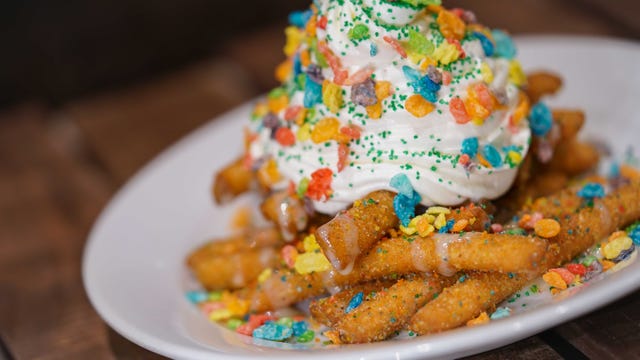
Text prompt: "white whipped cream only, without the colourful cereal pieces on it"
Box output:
[[249, 0, 531, 214]]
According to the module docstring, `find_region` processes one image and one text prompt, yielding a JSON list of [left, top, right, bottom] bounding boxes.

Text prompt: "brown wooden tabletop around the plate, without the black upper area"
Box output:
[[0, 0, 640, 359]]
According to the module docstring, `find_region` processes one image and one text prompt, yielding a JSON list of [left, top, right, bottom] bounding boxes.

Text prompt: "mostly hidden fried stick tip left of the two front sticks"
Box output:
[[309, 280, 396, 326]]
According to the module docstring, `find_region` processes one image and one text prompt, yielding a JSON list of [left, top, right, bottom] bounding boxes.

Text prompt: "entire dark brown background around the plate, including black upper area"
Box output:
[[0, 0, 640, 359]]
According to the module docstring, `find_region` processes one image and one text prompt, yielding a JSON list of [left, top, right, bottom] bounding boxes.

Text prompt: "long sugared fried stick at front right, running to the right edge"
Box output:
[[409, 180, 640, 334]]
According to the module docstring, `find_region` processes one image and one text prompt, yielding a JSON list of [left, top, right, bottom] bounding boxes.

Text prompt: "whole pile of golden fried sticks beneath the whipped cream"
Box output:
[[187, 72, 640, 344]]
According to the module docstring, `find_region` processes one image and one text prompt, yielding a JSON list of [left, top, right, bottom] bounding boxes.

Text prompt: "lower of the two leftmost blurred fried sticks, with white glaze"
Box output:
[[191, 247, 280, 290]]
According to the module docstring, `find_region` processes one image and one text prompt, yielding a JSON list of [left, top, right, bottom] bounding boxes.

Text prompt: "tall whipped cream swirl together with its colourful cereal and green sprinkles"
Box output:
[[247, 0, 531, 214]]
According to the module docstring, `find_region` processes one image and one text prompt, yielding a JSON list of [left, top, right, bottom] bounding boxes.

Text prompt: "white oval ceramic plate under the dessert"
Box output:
[[83, 37, 640, 359]]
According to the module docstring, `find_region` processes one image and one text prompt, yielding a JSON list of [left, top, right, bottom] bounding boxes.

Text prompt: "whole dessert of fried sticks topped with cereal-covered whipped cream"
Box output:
[[187, 0, 640, 344]]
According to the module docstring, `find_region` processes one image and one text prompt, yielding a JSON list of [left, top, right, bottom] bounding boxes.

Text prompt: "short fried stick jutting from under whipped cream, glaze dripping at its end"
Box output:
[[315, 190, 398, 271]]
